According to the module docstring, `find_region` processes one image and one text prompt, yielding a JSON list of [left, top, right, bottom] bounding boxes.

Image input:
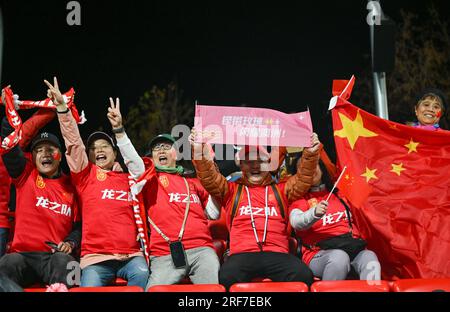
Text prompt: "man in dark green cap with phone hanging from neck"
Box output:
[[143, 134, 220, 287]]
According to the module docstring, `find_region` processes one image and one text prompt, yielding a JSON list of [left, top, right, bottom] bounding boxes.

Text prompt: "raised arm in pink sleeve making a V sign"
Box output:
[[44, 77, 89, 173]]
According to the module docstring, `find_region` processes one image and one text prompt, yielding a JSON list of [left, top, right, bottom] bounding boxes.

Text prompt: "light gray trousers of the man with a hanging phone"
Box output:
[[146, 247, 220, 289]]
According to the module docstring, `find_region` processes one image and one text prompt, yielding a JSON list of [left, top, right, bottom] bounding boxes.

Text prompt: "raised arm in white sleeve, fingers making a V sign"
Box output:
[[107, 98, 145, 179]]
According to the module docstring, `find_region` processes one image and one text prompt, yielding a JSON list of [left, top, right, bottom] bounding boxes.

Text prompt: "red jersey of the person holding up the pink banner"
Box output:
[[224, 182, 289, 255]]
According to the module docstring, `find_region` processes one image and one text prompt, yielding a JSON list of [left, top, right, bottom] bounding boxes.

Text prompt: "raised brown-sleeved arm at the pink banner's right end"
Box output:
[[285, 133, 320, 203]]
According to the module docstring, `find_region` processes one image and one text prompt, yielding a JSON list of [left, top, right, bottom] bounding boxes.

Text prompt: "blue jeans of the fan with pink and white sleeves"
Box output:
[[81, 257, 149, 289]]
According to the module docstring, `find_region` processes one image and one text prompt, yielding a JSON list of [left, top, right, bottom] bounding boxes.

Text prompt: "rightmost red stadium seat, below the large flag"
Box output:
[[392, 278, 450, 292]]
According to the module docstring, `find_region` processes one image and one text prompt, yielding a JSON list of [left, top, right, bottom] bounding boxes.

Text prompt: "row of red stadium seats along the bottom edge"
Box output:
[[25, 279, 450, 293]]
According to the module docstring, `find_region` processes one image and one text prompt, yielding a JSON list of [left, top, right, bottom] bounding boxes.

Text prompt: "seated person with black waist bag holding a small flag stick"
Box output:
[[290, 161, 381, 280]]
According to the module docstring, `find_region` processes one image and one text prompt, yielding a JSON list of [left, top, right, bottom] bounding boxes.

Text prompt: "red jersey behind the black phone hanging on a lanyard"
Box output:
[[143, 172, 213, 256]]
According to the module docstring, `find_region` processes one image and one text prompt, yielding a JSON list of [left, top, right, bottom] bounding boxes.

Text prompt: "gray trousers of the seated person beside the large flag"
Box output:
[[309, 249, 381, 281]]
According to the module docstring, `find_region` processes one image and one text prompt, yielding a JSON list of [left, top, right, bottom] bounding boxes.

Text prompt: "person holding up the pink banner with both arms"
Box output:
[[190, 130, 320, 288]]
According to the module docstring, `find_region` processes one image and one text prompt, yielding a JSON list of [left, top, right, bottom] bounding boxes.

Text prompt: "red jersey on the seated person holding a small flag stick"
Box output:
[[291, 190, 360, 265]]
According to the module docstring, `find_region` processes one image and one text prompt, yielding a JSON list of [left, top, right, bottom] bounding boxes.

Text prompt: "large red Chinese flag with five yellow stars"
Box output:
[[332, 97, 450, 279]]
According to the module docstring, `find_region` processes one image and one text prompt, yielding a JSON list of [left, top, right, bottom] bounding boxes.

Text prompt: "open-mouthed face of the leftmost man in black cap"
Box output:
[[32, 142, 61, 178]]
